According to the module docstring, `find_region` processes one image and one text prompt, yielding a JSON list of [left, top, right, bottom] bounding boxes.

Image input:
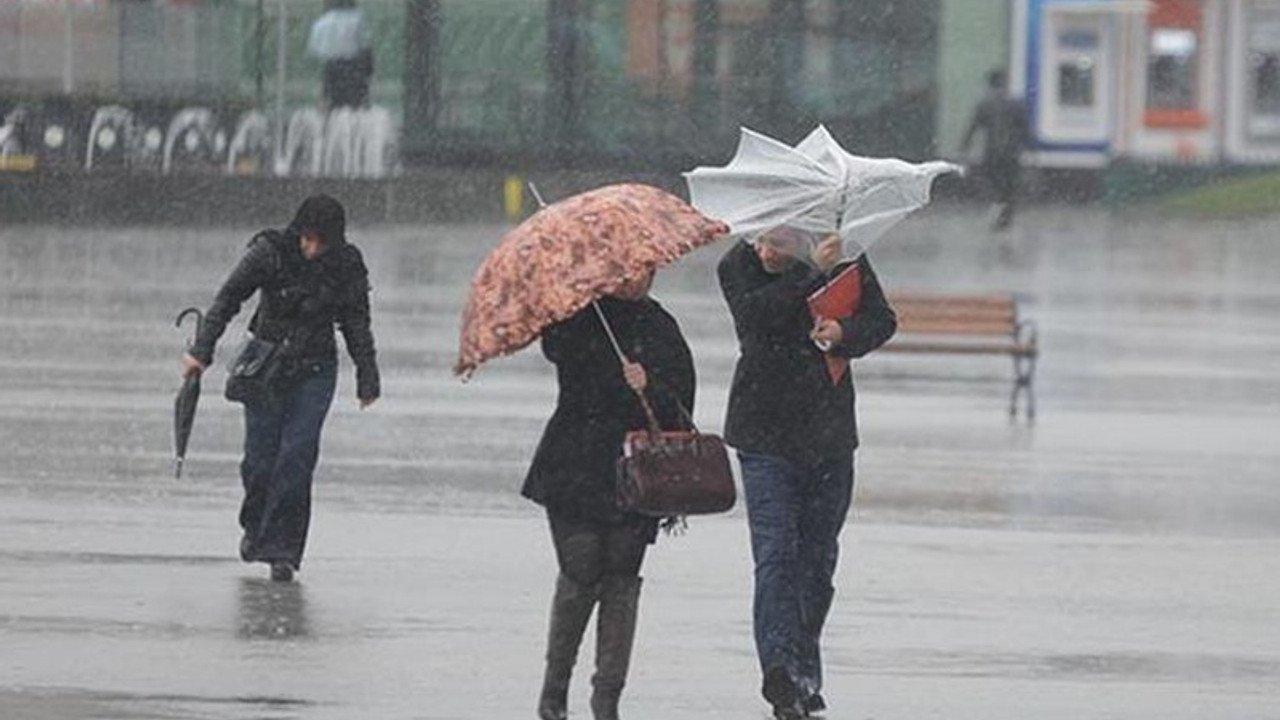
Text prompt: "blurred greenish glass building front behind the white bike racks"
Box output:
[[0, 0, 940, 167]]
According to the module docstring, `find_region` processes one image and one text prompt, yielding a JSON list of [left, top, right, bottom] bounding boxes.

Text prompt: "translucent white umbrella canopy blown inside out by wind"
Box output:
[[685, 126, 964, 259]]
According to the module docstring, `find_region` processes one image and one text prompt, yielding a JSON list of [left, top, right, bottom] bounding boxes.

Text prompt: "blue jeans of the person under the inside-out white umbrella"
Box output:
[[737, 452, 854, 696]]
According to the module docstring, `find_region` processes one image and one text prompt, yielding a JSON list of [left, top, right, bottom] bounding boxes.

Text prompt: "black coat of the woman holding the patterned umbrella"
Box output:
[[522, 297, 695, 523]]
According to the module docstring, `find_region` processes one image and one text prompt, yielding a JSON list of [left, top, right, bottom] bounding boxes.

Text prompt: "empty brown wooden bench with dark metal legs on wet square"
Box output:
[[878, 293, 1038, 421]]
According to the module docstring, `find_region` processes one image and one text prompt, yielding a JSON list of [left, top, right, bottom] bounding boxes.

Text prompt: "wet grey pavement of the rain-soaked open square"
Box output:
[[0, 206, 1280, 720]]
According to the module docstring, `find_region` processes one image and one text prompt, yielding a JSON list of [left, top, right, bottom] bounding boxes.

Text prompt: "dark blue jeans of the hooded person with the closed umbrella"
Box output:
[[239, 363, 338, 568]]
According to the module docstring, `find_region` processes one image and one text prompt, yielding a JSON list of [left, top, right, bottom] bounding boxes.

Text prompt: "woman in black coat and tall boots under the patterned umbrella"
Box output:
[[522, 274, 695, 720]]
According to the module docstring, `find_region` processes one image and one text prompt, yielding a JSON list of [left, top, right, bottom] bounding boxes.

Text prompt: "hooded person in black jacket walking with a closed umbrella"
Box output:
[[182, 195, 380, 582]]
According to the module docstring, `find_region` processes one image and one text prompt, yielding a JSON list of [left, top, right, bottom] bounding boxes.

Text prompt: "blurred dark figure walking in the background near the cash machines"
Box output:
[[960, 70, 1030, 231]]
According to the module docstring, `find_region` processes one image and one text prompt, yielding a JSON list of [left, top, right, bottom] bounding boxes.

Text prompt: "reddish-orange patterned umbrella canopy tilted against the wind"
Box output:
[[453, 184, 728, 378]]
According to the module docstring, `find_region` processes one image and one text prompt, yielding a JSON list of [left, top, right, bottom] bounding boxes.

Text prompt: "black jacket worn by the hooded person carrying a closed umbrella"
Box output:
[[191, 229, 381, 400]]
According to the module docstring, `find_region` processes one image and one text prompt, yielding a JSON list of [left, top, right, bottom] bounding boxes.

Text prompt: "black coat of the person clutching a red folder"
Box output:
[[718, 242, 897, 465]]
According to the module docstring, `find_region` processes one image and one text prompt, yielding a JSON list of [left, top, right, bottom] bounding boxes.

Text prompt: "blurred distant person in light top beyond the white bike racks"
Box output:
[[307, 0, 374, 110]]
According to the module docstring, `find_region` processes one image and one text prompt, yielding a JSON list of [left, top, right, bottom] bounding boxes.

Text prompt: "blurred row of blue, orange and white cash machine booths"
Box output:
[[1011, 0, 1280, 167]]
